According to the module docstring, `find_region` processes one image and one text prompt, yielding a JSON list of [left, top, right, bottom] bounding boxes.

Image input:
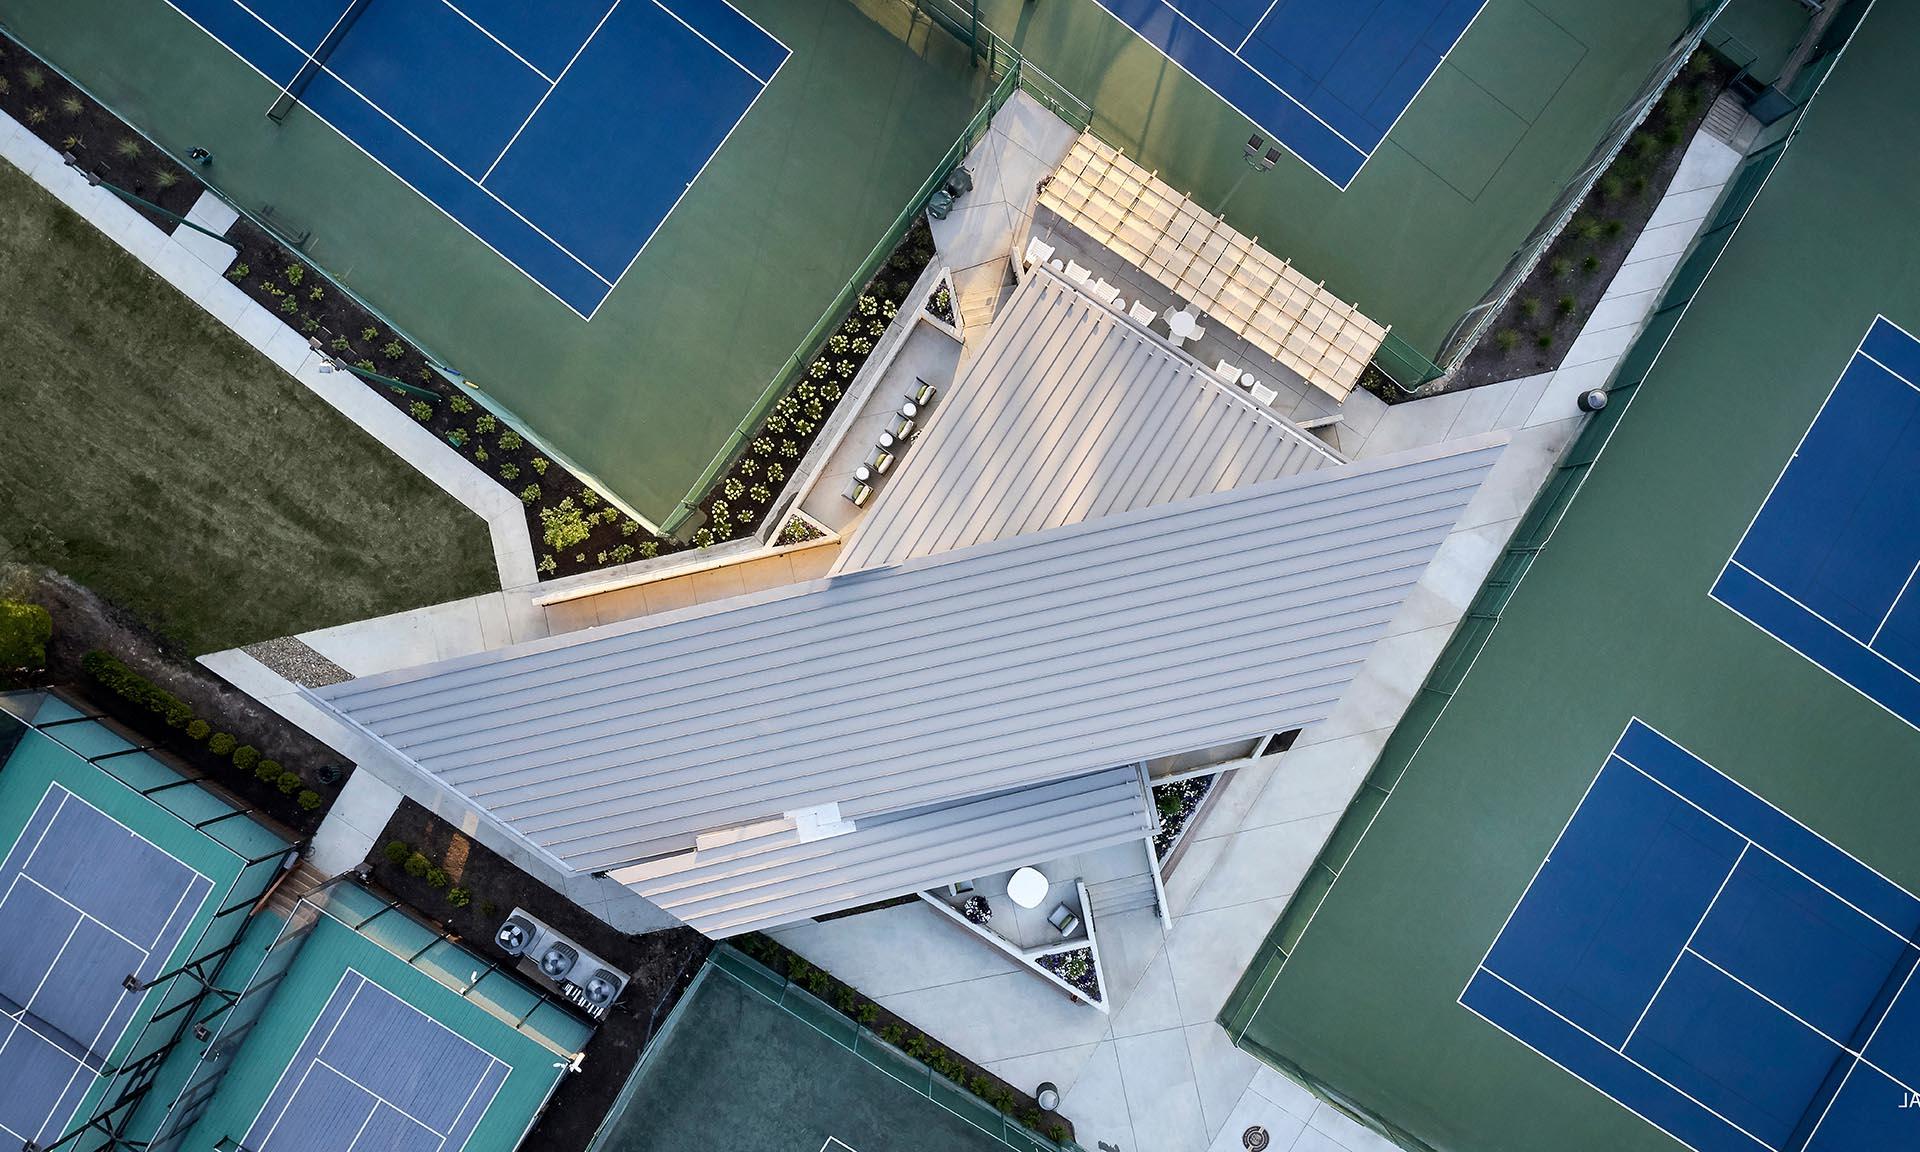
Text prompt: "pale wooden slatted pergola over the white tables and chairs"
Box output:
[[1041, 132, 1386, 401]]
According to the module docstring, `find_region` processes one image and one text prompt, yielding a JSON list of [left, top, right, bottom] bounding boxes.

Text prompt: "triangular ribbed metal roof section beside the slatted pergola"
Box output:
[[835, 267, 1340, 572]]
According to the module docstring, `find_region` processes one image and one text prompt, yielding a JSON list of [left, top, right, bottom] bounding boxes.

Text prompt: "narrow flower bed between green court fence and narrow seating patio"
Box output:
[[693, 219, 933, 547]]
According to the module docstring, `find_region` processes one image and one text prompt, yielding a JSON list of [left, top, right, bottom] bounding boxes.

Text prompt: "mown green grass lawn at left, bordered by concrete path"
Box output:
[[0, 163, 497, 655]]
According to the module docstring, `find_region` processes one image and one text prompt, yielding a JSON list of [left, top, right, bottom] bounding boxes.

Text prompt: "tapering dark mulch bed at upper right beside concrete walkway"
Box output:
[[1443, 50, 1734, 391]]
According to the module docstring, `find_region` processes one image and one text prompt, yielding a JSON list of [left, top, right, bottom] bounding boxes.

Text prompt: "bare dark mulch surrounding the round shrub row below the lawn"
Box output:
[[0, 563, 353, 833]]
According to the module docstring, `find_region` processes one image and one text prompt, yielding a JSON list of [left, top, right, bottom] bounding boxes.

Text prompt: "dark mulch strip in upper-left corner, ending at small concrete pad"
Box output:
[[0, 36, 200, 232]]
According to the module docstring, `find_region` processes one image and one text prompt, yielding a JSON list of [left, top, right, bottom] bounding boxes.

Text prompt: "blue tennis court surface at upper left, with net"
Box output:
[[167, 0, 787, 319]]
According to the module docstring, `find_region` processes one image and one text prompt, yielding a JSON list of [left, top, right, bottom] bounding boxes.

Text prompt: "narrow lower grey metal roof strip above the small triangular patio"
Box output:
[[611, 766, 1152, 939]]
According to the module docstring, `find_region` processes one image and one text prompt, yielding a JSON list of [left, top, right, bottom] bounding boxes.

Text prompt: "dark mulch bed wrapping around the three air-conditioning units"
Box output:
[[371, 801, 712, 1152]]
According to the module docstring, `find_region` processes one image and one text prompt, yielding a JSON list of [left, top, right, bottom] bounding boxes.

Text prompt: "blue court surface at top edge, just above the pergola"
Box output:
[[1100, 0, 1484, 188]]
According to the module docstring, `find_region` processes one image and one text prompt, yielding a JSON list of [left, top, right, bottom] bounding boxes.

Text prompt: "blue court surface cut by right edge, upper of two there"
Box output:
[[1713, 317, 1920, 728]]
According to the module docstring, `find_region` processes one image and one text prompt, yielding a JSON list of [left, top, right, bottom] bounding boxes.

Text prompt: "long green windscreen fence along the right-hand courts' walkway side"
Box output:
[[1219, 87, 1799, 1152]]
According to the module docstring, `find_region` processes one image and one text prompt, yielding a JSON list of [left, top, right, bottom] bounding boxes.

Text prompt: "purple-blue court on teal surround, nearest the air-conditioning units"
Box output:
[[244, 968, 513, 1152]]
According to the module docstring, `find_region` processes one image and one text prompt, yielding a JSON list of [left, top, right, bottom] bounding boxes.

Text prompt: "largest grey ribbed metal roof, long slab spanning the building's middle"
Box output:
[[313, 434, 1505, 872]]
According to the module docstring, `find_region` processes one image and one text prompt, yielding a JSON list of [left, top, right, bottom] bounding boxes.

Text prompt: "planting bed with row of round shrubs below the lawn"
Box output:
[[0, 564, 353, 841]]
